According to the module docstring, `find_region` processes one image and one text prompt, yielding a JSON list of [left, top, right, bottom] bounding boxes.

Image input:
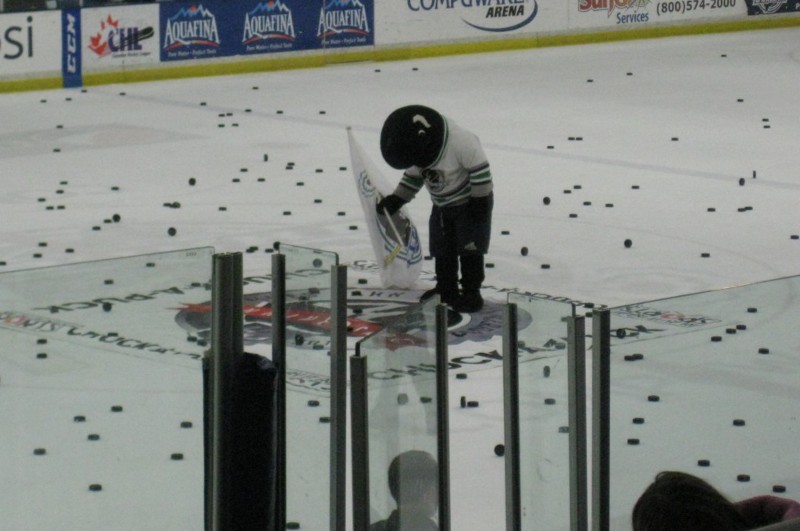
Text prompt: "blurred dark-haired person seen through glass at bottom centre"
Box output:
[[369, 450, 439, 531]]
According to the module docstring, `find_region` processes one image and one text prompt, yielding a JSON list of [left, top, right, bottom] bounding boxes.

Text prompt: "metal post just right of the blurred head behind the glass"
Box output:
[[436, 304, 450, 531]]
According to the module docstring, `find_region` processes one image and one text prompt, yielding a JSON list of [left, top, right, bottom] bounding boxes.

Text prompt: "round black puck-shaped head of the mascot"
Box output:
[[381, 105, 444, 170]]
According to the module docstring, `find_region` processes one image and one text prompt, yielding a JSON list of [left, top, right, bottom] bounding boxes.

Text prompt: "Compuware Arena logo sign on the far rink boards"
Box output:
[[406, 0, 539, 33]]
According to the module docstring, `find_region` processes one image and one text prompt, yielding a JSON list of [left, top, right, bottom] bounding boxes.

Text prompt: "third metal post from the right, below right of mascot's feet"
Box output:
[[503, 304, 522, 531]]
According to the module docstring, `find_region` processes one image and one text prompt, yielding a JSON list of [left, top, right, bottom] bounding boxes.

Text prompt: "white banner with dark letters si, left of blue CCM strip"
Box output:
[[0, 12, 61, 78]]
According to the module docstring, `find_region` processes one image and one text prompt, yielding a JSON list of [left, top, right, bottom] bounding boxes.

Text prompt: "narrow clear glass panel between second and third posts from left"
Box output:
[[280, 244, 339, 529]]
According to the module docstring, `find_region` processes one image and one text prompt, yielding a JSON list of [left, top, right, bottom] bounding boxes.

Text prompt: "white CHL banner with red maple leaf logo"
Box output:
[[80, 5, 158, 72]]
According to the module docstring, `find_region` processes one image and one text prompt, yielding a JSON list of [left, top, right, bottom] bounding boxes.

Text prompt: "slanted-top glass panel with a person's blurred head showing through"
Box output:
[[360, 299, 439, 530]]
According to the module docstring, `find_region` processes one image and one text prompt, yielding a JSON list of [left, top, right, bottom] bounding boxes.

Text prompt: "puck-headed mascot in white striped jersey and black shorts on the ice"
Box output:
[[377, 105, 494, 313]]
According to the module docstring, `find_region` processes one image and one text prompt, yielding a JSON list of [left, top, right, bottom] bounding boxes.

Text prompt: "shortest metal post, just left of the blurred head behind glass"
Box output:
[[350, 350, 370, 531]]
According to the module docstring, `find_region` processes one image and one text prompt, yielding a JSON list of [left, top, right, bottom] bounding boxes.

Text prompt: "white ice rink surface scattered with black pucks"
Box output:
[[0, 29, 800, 531]]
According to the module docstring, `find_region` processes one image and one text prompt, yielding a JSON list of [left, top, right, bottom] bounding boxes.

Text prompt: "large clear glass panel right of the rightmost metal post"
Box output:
[[610, 277, 800, 529]]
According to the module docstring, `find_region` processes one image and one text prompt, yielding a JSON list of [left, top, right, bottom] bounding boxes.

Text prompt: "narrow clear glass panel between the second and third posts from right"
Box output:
[[508, 293, 575, 531]]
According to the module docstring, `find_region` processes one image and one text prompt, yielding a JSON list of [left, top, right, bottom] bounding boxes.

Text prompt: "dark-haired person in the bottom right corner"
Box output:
[[632, 472, 800, 531]]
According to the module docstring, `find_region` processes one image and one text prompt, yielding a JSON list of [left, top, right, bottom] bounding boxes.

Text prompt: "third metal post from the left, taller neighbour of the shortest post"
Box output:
[[330, 265, 347, 531]]
